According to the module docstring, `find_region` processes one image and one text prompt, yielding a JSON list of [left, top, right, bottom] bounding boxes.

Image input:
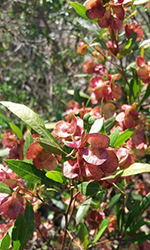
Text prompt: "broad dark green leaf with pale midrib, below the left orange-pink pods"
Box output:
[[5, 160, 51, 186]]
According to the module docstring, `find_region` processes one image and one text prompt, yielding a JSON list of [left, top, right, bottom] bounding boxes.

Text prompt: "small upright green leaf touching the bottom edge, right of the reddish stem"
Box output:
[[77, 223, 88, 250]]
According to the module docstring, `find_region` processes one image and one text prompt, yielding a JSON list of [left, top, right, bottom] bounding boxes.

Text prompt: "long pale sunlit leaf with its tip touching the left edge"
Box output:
[[0, 101, 49, 138]]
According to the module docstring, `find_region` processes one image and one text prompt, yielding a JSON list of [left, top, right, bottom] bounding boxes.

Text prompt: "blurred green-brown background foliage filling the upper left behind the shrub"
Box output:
[[0, 0, 150, 124]]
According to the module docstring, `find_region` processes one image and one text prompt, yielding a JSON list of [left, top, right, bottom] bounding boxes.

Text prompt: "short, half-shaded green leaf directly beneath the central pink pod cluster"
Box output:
[[78, 181, 100, 196]]
